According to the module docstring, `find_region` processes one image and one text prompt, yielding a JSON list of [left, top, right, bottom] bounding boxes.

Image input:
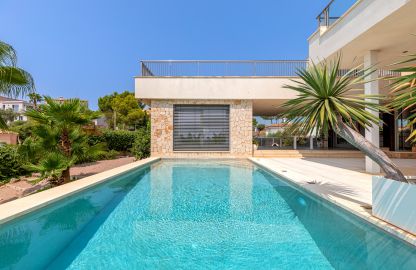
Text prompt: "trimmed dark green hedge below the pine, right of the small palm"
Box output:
[[103, 130, 136, 152]]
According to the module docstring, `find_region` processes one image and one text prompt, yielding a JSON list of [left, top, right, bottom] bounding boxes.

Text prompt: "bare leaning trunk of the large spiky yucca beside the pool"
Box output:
[[334, 120, 409, 183]]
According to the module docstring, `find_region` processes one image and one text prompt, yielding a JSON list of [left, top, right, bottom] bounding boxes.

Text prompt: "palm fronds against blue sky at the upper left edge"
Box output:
[[0, 41, 34, 129]]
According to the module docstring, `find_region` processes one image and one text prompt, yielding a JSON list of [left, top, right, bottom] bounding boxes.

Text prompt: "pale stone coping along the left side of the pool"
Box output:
[[0, 157, 161, 225]]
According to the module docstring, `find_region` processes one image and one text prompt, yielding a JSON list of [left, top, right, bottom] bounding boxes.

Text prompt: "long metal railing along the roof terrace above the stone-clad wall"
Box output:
[[140, 60, 308, 77]]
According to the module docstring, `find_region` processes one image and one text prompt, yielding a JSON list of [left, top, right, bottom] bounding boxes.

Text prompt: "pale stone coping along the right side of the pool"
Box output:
[[248, 157, 416, 247]]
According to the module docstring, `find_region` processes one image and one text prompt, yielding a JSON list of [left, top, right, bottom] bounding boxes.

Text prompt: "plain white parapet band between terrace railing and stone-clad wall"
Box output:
[[135, 77, 296, 100]]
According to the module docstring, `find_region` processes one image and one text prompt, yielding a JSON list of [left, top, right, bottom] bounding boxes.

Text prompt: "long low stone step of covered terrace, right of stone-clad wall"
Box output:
[[253, 150, 364, 158]]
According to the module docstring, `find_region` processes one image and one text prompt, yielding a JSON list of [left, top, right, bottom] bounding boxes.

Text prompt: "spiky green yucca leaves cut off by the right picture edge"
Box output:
[[390, 54, 416, 144]]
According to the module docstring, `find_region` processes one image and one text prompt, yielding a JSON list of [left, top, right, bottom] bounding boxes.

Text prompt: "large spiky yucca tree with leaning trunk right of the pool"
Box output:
[[281, 57, 407, 182]]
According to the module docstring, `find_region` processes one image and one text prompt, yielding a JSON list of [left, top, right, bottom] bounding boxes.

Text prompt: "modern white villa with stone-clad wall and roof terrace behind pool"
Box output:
[[135, 0, 416, 173]]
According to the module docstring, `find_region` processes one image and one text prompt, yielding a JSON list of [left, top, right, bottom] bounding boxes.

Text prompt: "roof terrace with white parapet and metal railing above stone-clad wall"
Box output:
[[135, 60, 398, 115]]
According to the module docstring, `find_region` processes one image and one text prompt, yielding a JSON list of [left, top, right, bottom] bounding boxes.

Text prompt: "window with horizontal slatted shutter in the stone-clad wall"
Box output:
[[173, 105, 230, 151]]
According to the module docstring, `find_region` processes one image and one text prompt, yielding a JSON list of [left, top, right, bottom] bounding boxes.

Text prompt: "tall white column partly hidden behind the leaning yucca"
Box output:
[[364, 51, 380, 173]]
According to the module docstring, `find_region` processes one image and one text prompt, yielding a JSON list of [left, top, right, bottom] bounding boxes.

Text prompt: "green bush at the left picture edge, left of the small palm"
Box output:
[[0, 145, 27, 182]]
